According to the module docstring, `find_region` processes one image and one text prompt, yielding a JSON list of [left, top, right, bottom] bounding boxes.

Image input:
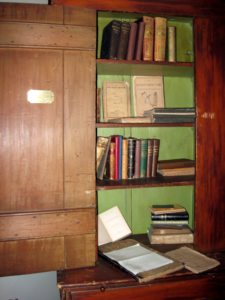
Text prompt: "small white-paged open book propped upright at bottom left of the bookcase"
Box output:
[[98, 206, 131, 245]]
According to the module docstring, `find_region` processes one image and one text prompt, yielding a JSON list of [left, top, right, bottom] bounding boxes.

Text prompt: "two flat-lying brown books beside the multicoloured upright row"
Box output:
[[157, 158, 195, 176]]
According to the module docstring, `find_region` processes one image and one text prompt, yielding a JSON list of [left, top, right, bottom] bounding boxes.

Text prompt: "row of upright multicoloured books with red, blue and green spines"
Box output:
[[96, 135, 160, 180]]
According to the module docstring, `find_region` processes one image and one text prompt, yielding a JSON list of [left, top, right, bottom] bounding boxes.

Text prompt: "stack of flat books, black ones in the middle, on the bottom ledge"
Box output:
[[147, 204, 194, 244]]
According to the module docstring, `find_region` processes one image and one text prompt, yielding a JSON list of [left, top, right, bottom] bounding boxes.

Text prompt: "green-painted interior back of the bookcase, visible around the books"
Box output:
[[96, 12, 195, 234]]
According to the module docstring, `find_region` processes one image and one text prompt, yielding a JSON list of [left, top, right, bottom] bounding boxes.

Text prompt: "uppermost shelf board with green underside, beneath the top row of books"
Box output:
[[97, 59, 194, 77]]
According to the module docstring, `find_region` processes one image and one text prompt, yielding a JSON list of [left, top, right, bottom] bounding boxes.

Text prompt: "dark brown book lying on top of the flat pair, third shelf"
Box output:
[[157, 158, 195, 170]]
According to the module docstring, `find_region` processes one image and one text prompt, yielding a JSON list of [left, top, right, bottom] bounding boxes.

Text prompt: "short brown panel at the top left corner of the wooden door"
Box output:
[[0, 3, 63, 24]]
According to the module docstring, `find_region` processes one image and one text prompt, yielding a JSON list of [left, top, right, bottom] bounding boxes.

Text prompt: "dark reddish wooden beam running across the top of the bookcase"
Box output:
[[51, 0, 225, 17]]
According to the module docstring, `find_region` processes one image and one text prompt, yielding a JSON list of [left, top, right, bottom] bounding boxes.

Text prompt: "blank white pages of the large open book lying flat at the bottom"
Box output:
[[104, 244, 173, 275]]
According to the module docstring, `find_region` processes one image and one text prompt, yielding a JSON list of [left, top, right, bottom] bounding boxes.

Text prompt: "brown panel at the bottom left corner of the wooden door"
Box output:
[[0, 237, 65, 276]]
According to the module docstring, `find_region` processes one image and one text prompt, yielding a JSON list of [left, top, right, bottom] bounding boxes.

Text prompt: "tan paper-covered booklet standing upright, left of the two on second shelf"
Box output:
[[102, 81, 131, 122]]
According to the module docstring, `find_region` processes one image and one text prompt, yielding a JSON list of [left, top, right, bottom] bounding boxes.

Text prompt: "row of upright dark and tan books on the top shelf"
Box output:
[[100, 16, 176, 61]]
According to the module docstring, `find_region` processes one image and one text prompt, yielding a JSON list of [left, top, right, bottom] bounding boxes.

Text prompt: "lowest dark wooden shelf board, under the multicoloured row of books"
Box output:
[[96, 175, 195, 191]]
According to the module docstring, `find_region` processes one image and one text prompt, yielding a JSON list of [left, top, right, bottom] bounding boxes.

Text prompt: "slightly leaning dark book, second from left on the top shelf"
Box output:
[[117, 21, 130, 59]]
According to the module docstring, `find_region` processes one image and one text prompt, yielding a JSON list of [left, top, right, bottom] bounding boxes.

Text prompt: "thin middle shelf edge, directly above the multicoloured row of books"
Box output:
[[95, 123, 195, 128]]
